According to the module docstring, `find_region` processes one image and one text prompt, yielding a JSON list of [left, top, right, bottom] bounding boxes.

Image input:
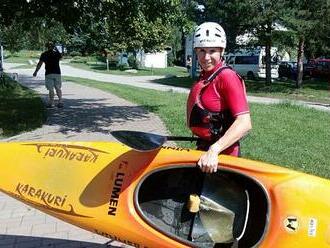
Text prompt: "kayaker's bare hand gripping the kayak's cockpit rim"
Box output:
[[197, 143, 221, 173]]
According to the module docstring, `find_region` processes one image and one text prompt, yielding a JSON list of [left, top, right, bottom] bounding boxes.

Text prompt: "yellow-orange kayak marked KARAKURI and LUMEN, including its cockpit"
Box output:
[[0, 142, 330, 248]]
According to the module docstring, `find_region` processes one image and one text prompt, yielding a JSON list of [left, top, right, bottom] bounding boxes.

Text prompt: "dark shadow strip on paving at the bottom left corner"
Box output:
[[0, 235, 122, 248]]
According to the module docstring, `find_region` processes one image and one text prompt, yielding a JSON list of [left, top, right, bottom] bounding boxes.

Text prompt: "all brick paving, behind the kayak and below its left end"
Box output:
[[0, 63, 170, 248]]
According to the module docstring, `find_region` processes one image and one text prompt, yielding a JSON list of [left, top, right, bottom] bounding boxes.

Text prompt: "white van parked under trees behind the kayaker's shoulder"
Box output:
[[225, 47, 278, 79]]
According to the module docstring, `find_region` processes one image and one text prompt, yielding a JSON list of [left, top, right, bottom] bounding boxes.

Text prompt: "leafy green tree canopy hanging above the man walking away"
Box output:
[[0, 0, 193, 59]]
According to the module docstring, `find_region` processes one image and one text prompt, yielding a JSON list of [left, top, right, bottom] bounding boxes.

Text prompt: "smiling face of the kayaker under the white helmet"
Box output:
[[196, 47, 222, 71]]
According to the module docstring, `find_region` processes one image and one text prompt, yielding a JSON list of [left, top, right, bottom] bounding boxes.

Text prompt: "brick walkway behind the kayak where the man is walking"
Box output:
[[5, 74, 170, 141]]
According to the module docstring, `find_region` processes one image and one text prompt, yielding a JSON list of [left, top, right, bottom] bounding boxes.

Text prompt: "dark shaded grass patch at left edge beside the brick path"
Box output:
[[0, 77, 46, 137]]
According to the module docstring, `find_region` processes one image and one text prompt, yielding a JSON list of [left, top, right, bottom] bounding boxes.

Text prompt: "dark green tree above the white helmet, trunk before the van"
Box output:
[[205, 0, 287, 84]]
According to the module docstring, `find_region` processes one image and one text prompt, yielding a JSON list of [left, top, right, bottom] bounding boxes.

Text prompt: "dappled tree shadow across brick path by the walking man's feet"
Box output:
[[14, 74, 164, 134]]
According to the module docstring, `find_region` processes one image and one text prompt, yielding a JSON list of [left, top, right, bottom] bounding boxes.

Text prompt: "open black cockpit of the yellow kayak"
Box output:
[[135, 166, 269, 248]]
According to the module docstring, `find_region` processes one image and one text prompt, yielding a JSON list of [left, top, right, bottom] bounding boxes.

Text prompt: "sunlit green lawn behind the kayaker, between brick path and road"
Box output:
[[66, 77, 330, 178]]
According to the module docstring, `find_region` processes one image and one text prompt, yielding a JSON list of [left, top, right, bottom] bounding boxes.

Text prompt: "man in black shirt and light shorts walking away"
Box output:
[[33, 42, 63, 108]]
